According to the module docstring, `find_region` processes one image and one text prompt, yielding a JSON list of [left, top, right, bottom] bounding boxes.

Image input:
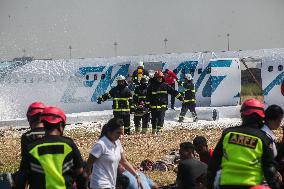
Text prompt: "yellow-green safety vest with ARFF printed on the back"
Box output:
[[220, 132, 264, 186]]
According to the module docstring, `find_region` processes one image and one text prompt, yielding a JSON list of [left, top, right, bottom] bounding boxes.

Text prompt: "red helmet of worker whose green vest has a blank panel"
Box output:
[[40, 106, 66, 124]]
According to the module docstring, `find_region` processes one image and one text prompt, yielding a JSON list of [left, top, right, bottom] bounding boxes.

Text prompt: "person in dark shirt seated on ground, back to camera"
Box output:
[[176, 142, 207, 189]]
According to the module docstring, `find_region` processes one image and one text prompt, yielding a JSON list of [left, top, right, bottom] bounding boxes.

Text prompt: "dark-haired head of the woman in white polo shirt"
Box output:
[[100, 118, 124, 142]]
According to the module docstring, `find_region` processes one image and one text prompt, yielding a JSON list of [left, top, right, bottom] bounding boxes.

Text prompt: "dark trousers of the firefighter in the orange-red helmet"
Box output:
[[151, 109, 166, 132]]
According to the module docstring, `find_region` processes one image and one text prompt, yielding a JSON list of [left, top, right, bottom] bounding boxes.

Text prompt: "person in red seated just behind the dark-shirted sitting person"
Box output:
[[193, 136, 213, 165]]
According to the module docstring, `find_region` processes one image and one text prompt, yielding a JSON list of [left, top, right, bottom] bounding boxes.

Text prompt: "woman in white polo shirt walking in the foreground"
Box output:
[[86, 118, 143, 189]]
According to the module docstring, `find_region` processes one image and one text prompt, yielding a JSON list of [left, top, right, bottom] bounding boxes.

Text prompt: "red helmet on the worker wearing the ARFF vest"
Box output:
[[241, 98, 265, 118]]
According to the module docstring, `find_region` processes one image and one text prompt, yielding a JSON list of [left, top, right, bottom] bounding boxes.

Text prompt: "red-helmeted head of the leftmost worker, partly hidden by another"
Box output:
[[27, 102, 45, 129]]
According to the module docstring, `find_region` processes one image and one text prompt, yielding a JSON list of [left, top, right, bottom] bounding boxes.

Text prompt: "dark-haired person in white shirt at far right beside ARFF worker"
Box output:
[[261, 105, 283, 157]]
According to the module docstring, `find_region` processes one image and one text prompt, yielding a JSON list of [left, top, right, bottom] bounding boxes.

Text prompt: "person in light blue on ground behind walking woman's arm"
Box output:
[[118, 164, 159, 189]]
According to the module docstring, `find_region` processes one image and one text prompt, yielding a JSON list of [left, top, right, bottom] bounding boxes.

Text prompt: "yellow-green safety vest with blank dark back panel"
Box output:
[[29, 142, 73, 189]]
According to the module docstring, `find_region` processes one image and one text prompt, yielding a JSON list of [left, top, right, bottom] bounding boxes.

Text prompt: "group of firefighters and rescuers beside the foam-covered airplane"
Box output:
[[97, 62, 197, 134]]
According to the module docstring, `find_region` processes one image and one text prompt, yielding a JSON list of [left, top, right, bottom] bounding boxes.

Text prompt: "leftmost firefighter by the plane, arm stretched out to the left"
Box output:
[[97, 75, 134, 135]]
